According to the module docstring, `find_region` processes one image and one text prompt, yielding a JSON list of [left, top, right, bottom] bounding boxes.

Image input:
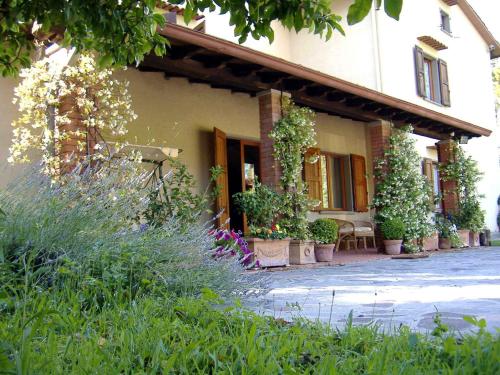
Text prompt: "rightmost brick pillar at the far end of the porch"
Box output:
[[436, 139, 458, 215]]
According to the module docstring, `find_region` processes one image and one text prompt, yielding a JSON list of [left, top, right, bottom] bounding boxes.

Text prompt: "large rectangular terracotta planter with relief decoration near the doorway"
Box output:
[[246, 238, 290, 267]]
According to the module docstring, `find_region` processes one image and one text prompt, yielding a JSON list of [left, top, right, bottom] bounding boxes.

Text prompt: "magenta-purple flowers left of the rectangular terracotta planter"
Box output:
[[212, 229, 259, 268]]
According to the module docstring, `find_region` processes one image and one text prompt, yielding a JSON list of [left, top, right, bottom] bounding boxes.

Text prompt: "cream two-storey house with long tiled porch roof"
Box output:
[[0, 0, 500, 235]]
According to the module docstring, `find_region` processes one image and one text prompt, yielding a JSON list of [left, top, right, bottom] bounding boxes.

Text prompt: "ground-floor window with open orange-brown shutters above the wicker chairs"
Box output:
[[304, 149, 368, 212]]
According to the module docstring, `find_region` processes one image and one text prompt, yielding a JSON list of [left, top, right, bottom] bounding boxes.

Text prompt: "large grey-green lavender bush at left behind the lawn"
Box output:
[[0, 162, 258, 303]]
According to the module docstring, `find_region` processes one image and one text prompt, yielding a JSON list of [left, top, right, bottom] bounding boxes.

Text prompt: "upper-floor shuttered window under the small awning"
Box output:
[[415, 46, 450, 106]]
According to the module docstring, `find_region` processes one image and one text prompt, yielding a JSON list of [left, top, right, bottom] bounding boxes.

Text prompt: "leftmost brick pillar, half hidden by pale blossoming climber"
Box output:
[[56, 95, 97, 173]]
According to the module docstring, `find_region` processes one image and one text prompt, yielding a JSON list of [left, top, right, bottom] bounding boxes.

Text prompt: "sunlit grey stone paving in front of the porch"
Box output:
[[247, 247, 500, 332]]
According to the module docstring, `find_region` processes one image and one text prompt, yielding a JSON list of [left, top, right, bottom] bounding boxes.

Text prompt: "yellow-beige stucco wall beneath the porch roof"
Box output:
[[117, 69, 372, 218]]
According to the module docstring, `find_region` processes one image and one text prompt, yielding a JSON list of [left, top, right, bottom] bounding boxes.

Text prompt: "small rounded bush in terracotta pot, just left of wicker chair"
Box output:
[[309, 219, 339, 262]]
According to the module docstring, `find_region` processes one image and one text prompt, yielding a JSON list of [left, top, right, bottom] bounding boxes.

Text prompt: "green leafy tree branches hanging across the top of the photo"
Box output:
[[0, 0, 402, 76]]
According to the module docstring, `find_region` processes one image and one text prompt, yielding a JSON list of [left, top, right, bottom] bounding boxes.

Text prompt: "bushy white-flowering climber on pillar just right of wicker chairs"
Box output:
[[372, 127, 432, 245]]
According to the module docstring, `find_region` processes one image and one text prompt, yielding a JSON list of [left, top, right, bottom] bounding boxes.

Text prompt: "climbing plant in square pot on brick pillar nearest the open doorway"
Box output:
[[269, 97, 316, 264]]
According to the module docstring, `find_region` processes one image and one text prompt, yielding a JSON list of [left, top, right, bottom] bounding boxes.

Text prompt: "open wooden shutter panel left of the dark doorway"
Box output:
[[214, 128, 229, 228]]
